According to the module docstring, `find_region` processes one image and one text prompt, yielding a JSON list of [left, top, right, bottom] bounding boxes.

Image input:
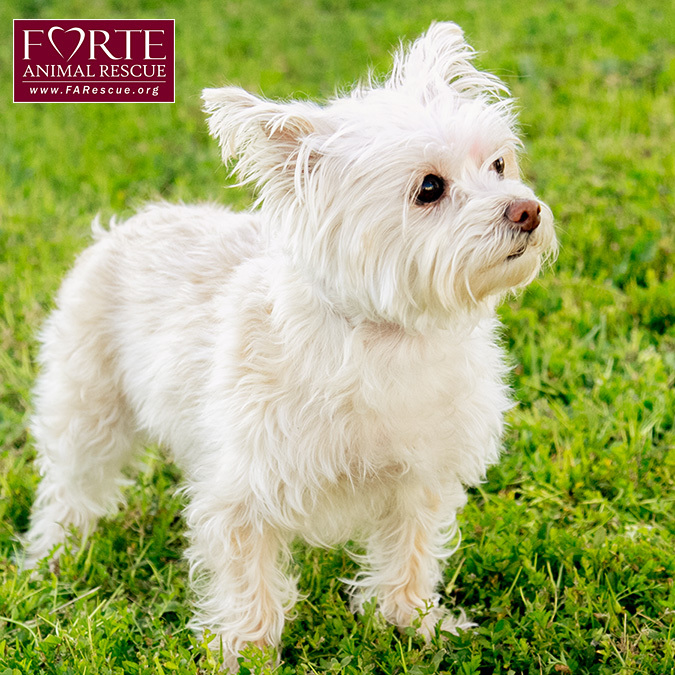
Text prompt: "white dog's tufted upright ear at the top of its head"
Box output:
[[387, 21, 508, 100]]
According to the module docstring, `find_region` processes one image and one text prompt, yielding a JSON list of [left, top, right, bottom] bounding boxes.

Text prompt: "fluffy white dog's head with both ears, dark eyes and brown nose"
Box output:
[[203, 23, 555, 329]]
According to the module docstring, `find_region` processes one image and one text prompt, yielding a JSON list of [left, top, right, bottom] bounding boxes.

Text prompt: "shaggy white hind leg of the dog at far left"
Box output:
[[24, 258, 135, 567]]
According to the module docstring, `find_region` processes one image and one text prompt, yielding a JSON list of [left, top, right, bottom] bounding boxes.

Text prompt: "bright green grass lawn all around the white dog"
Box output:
[[0, 0, 675, 675]]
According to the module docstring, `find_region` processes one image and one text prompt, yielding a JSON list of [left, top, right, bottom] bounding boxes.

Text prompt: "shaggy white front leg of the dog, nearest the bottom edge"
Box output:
[[187, 495, 297, 672]]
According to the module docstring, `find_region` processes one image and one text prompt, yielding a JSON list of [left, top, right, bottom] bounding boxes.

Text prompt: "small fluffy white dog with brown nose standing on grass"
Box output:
[[27, 23, 555, 668]]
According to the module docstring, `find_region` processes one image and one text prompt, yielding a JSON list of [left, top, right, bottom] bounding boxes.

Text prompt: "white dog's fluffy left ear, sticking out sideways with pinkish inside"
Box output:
[[202, 87, 320, 190]]
